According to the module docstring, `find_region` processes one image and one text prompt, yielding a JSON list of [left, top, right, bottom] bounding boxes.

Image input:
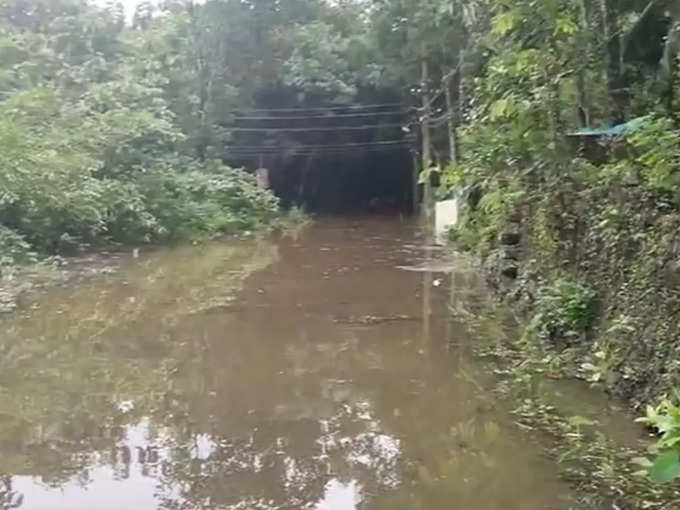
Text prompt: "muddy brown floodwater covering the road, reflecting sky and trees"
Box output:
[[0, 220, 620, 510]]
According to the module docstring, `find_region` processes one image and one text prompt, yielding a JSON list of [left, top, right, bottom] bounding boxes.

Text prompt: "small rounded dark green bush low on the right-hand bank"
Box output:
[[528, 279, 595, 343]]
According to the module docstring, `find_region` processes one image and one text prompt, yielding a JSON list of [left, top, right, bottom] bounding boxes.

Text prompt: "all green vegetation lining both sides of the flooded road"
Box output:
[[0, 0, 680, 498]]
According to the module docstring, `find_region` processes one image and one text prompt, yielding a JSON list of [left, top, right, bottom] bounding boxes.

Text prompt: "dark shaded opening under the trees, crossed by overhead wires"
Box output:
[[225, 89, 415, 215]]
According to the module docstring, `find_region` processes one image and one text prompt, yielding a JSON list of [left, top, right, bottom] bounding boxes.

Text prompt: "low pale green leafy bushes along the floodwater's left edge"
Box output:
[[0, 87, 278, 260]]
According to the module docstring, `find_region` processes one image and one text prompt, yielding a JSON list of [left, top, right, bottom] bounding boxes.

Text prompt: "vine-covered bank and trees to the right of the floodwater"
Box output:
[[424, 0, 680, 484]]
